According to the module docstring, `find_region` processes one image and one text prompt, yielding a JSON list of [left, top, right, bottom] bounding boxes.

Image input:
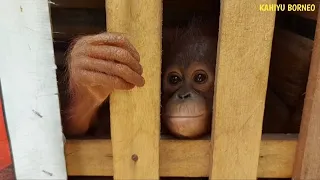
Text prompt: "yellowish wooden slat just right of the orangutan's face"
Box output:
[[209, 0, 276, 180]]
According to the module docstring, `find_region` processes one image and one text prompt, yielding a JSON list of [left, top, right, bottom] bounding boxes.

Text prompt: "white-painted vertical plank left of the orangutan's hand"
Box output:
[[0, 0, 67, 180]]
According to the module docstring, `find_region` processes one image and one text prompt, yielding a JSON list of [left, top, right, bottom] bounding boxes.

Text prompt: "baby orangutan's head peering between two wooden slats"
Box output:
[[162, 28, 217, 138]]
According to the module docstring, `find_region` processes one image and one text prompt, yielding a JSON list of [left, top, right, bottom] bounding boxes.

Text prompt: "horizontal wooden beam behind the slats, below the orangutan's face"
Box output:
[[65, 135, 297, 178]]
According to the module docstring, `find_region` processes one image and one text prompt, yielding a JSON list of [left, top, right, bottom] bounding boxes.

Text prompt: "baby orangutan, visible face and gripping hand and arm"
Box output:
[[63, 20, 216, 138]]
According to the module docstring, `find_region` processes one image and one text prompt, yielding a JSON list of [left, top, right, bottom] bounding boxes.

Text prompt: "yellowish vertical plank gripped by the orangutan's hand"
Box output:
[[106, 0, 162, 180]]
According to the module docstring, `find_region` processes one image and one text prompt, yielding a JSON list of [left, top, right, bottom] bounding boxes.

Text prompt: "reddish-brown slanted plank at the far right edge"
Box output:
[[293, 8, 320, 179]]
